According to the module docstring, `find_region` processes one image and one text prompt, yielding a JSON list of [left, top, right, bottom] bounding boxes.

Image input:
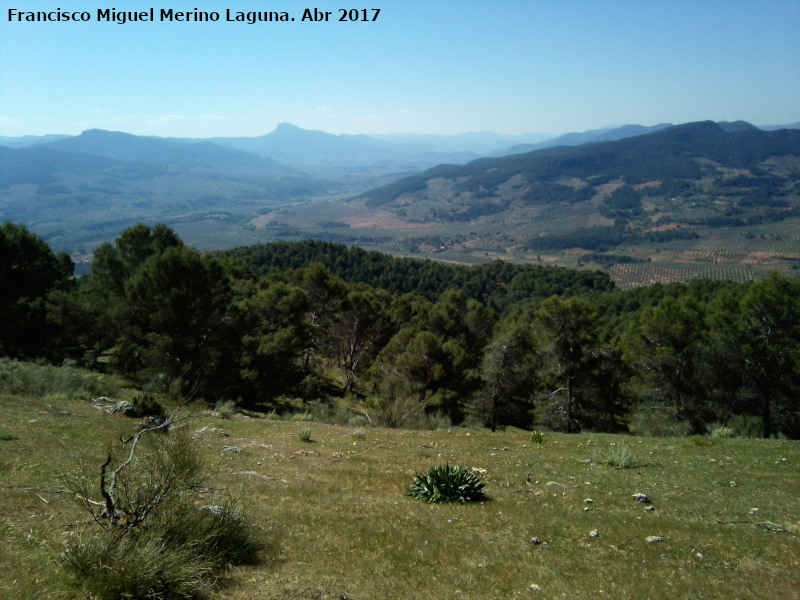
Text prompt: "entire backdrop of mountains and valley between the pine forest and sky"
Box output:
[[0, 121, 800, 280]]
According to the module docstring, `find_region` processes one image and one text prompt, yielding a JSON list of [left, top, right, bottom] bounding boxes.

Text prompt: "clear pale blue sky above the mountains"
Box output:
[[0, 0, 800, 137]]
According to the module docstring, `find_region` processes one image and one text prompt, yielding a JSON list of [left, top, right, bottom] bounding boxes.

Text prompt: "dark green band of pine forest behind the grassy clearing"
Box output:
[[0, 223, 800, 438]]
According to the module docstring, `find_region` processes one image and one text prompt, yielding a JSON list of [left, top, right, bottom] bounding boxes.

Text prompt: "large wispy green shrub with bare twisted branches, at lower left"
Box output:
[[58, 420, 263, 600]]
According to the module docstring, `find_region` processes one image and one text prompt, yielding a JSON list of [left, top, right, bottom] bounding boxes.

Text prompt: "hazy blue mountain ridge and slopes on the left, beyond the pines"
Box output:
[[0, 130, 346, 254]]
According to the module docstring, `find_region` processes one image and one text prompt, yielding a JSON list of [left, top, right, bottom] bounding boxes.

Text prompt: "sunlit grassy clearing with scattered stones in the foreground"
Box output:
[[0, 368, 800, 600]]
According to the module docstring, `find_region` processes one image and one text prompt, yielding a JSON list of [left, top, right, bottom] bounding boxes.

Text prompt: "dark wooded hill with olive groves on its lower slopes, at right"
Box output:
[[359, 121, 800, 286]]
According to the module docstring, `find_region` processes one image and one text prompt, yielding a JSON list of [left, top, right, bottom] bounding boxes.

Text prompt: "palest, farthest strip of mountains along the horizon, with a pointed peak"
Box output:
[[0, 121, 800, 166]]
